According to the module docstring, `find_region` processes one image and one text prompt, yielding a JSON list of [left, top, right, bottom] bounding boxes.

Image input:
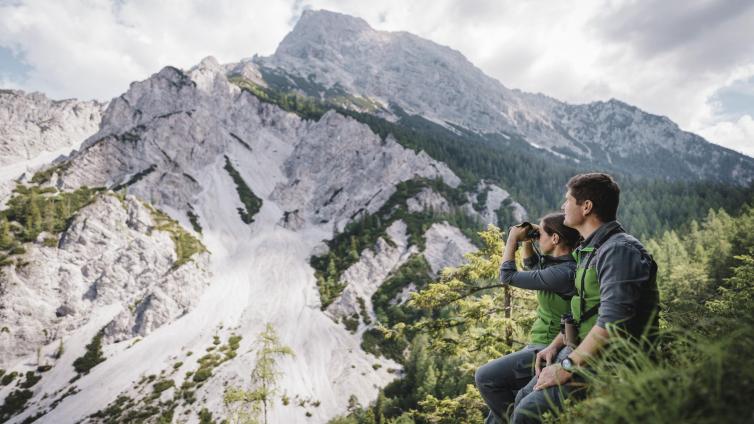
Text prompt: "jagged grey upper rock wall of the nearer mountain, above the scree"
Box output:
[[61, 58, 452, 232]]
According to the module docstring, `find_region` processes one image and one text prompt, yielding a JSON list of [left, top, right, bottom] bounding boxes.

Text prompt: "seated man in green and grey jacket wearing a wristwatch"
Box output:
[[511, 173, 659, 424]]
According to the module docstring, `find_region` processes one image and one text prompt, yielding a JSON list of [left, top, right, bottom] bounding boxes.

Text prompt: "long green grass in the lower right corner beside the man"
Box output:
[[547, 325, 754, 424]]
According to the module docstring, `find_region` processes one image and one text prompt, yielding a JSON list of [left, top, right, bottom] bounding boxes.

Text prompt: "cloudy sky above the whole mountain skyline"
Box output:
[[0, 0, 754, 156]]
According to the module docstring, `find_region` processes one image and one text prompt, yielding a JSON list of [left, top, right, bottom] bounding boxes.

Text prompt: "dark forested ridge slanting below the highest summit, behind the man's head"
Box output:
[[230, 73, 754, 238]]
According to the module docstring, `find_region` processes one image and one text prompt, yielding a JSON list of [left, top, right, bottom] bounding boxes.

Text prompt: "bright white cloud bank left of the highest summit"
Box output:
[[0, 0, 292, 100]]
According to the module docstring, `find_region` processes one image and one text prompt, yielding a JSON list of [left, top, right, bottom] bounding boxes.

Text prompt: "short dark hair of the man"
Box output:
[[566, 172, 620, 222]]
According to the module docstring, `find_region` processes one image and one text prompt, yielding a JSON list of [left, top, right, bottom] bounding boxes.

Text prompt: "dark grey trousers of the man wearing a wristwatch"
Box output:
[[510, 347, 586, 424]]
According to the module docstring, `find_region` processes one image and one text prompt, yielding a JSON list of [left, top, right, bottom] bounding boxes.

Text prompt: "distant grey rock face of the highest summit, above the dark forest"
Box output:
[[256, 10, 754, 184]]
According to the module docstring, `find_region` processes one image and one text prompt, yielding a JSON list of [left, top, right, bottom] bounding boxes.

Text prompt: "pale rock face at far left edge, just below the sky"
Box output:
[[0, 90, 104, 166]]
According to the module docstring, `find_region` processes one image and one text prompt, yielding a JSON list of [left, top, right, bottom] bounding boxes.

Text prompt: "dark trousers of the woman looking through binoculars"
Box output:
[[474, 344, 546, 424]]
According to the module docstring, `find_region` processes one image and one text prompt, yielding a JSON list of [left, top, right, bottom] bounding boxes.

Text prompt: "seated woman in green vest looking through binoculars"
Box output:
[[475, 213, 579, 424]]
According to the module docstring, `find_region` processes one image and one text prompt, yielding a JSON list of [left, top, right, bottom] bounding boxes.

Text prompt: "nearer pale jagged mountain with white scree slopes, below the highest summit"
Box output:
[[0, 58, 488, 422]]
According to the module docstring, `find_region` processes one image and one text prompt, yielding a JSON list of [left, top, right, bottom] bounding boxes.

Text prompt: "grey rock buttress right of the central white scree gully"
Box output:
[[271, 111, 460, 230]]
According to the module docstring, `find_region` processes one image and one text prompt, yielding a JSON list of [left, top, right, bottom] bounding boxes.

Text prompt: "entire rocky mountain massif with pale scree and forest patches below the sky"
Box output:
[[0, 7, 754, 423]]
